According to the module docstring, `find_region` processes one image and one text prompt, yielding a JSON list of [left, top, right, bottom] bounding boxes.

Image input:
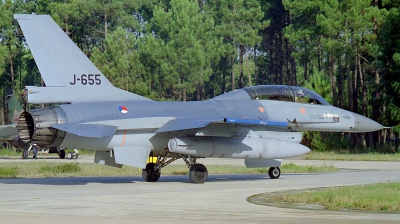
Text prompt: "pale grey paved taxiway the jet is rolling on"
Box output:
[[0, 156, 400, 224]]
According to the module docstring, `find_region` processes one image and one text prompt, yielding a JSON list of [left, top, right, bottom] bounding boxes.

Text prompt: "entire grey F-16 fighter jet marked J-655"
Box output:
[[10, 15, 383, 183]]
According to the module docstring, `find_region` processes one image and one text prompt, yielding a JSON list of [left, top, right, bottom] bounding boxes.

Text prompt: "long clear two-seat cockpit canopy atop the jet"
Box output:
[[243, 85, 330, 105]]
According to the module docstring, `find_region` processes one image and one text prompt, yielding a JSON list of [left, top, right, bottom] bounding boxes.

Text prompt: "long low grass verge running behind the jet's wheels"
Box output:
[[0, 161, 338, 178]]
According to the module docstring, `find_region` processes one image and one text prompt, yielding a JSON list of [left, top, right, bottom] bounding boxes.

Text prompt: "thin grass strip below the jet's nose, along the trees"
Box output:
[[304, 152, 400, 162]]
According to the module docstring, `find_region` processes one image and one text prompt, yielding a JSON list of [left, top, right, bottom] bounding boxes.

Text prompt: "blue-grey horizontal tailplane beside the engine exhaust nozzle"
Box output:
[[51, 124, 118, 138]]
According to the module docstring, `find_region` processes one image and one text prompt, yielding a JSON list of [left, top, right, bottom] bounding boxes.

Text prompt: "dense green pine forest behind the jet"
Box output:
[[0, 0, 400, 152]]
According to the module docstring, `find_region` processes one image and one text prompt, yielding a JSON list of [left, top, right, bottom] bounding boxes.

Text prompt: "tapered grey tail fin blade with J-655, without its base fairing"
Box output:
[[14, 14, 113, 87]]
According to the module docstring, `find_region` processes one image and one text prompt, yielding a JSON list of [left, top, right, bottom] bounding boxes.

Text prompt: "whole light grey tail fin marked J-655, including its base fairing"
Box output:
[[14, 14, 149, 103]]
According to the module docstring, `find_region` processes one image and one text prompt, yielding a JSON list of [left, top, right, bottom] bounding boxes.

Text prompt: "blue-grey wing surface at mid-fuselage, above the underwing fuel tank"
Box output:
[[156, 118, 219, 132]]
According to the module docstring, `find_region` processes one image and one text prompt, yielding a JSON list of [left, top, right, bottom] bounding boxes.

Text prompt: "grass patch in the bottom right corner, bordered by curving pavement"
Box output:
[[260, 183, 400, 212]]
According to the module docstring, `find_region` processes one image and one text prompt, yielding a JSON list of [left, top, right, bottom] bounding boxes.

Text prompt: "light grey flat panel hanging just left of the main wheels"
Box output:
[[113, 146, 151, 168]]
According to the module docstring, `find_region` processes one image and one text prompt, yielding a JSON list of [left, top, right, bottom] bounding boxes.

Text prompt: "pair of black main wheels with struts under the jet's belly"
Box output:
[[142, 154, 208, 184]]
